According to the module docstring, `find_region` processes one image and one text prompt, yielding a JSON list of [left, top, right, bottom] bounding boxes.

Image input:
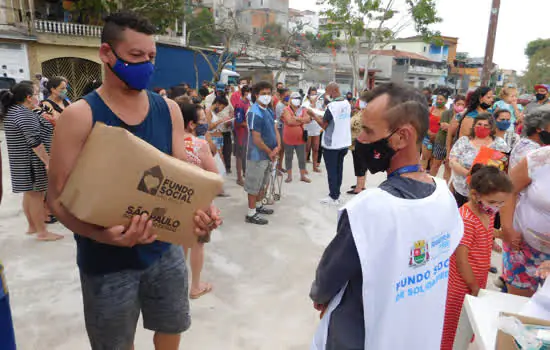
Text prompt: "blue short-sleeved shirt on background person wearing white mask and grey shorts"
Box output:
[[246, 103, 277, 162]]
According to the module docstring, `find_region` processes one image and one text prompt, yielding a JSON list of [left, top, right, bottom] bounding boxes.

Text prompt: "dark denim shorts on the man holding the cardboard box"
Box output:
[[80, 246, 191, 350]]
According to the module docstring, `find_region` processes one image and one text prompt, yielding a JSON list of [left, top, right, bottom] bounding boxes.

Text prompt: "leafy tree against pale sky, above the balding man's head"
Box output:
[[323, 0, 441, 91]]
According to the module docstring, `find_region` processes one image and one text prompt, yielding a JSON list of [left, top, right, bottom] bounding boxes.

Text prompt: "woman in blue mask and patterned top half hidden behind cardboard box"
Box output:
[[180, 104, 218, 299]]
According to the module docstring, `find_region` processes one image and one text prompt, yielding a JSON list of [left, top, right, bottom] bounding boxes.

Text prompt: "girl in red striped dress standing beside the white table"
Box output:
[[441, 164, 513, 350]]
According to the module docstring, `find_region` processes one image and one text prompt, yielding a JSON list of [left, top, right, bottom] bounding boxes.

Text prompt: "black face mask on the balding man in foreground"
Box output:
[[355, 131, 395, 174]]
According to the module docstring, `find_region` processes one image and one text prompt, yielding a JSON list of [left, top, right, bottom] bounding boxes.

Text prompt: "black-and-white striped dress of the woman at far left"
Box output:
[[4, 105, 53, 193]]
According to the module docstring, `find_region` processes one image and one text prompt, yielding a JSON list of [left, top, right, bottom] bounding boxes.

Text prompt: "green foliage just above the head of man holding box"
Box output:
[[118, 0, 185, 33]]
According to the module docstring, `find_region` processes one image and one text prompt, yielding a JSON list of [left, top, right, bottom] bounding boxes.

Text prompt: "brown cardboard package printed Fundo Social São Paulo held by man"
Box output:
[[60, 123, 223, 244]]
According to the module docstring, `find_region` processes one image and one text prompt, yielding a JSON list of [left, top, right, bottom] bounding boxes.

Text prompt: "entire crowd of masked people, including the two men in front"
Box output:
[[0, 12, 550, 350]]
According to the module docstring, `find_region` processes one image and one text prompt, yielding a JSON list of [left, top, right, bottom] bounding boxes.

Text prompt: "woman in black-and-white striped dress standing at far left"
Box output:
[[0, 81, 63, 241]]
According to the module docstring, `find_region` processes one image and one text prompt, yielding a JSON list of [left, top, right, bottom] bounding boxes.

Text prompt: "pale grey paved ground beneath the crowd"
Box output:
[[0, 135, 502, 350]]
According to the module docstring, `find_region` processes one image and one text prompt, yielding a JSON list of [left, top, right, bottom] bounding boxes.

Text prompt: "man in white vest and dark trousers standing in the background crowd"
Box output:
[[314, 83, 351, 205]]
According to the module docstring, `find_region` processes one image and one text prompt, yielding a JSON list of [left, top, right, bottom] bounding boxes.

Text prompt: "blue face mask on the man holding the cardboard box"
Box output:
[[109, 48, 155, 91]]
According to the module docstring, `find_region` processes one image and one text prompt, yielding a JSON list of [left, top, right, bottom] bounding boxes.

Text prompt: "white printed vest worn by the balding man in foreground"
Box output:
[[311, 179, 464, 350]]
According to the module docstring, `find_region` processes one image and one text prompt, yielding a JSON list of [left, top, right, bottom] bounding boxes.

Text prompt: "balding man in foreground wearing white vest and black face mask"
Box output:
[[310, 83, 463, 350]]
